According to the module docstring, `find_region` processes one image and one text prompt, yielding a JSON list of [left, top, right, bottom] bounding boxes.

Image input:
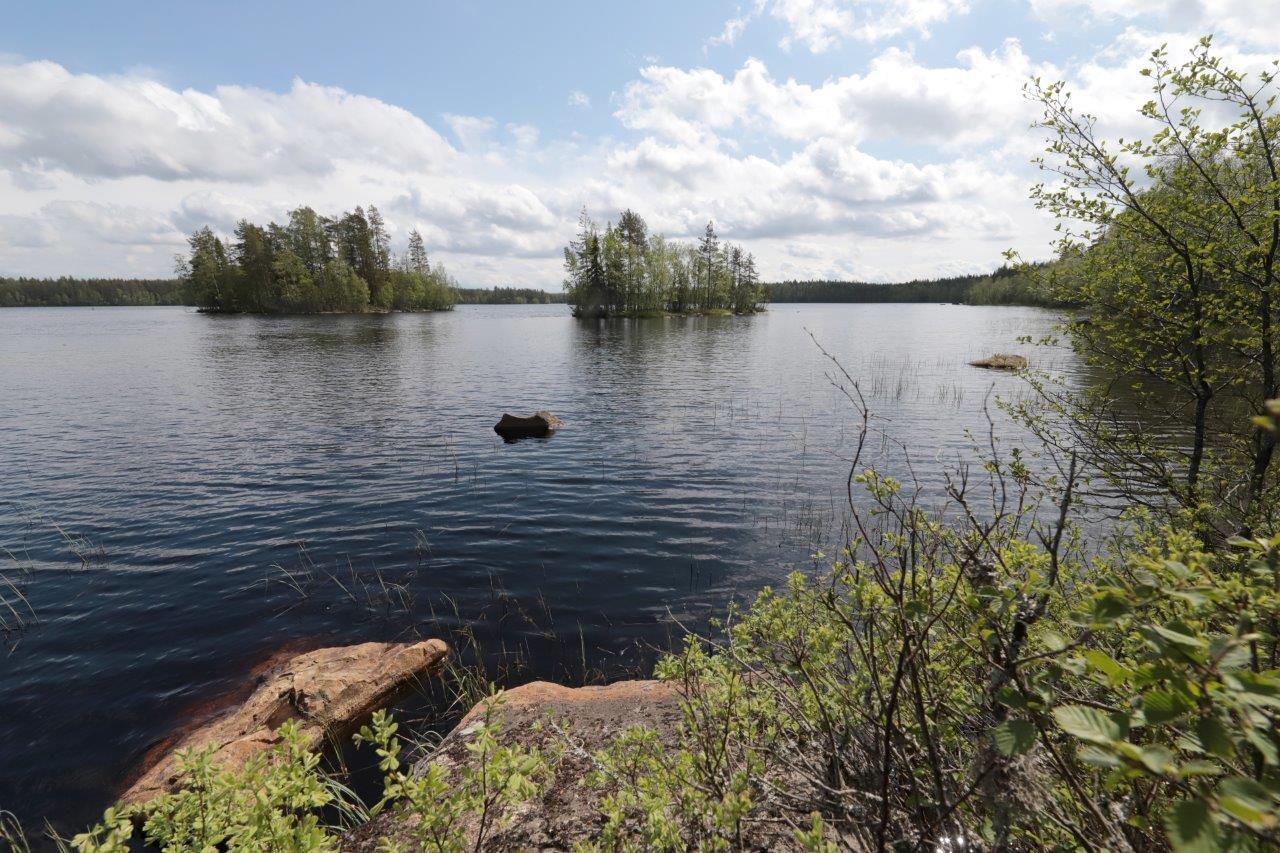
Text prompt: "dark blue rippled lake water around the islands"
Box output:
[[0, 305, 1074, 829]]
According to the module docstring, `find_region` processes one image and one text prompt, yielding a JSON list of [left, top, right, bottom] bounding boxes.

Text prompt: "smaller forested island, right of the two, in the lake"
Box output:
[[564, 210, 764, 316]]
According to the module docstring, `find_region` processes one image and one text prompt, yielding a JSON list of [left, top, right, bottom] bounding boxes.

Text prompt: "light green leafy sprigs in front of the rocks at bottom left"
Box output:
[[72, 694, 547, 853]]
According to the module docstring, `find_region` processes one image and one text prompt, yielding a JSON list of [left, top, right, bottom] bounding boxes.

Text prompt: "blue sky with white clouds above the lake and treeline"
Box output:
[[0, 0, 1280, 289]]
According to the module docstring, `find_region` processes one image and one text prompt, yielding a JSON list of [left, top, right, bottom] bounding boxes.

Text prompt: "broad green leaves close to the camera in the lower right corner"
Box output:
[[1023, 533, 1280, 850]]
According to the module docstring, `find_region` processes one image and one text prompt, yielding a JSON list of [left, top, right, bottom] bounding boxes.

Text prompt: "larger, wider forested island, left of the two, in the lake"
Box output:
[[178, 205, 457, 314]]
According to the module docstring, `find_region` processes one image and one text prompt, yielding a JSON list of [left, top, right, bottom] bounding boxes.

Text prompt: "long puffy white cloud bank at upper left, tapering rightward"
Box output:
[[0, 61, 453, 181]]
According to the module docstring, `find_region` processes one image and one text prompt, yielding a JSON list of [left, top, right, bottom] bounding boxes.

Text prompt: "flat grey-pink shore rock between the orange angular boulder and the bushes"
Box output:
[[342, 681, 681, 853]]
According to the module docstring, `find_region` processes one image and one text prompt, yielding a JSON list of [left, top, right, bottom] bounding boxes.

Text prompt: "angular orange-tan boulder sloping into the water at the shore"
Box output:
[[120, 639, 448, 804]]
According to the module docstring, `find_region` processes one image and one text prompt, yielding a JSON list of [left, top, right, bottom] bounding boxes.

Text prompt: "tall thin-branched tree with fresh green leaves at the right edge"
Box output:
[[1021, 37, 1280, 537]]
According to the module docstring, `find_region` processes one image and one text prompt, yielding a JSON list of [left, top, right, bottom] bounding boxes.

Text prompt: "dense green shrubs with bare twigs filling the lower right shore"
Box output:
[[578, 473, 1280, 850]]
